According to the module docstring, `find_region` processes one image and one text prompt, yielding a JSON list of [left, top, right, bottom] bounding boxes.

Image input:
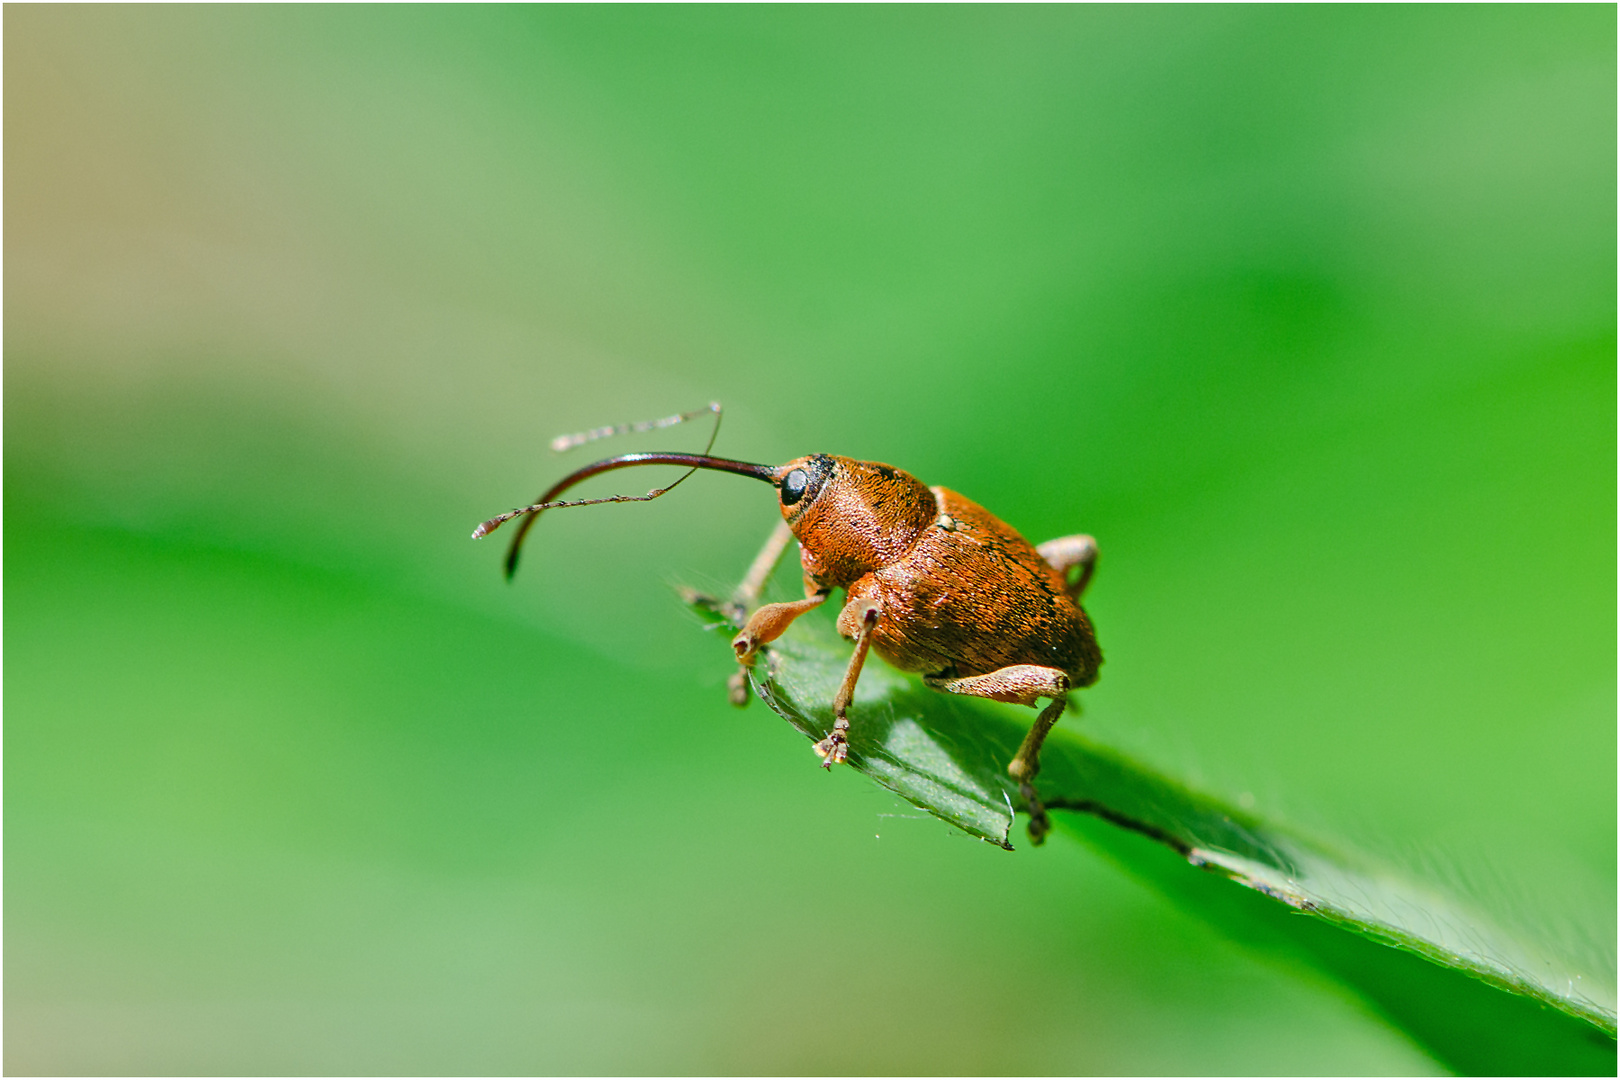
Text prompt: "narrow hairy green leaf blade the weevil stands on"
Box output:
[[687, 594, 1617, 1075]]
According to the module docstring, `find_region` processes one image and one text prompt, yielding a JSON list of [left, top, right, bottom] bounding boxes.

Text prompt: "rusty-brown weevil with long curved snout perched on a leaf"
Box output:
[[473, 405, 1103, 844]]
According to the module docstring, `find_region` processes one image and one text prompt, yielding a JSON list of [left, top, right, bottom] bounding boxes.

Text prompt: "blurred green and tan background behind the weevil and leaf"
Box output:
[[5, 5, 1617, 1074]]
